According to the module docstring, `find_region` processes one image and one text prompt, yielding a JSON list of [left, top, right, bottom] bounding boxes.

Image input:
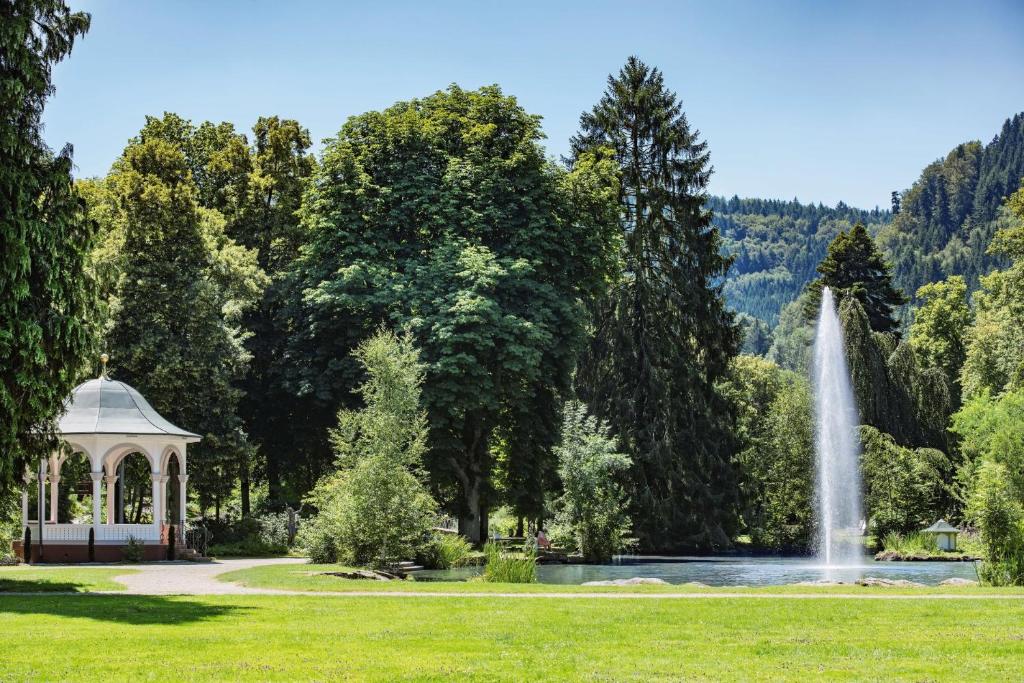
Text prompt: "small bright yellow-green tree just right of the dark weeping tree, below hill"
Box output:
[[909, 275, 972, 409]]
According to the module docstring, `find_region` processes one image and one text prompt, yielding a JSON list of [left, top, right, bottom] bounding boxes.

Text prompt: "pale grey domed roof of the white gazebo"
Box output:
[[57, 377, 200, 441]]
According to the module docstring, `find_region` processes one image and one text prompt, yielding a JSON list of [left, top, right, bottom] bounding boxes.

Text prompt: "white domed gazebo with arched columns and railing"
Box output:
[[17, 354, 200, 562]]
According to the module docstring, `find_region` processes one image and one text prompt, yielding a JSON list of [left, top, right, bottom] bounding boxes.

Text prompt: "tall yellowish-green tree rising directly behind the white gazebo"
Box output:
[[105, 139, 265, 503]]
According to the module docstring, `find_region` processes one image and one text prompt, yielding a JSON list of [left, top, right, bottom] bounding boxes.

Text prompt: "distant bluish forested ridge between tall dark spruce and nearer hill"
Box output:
[[708, 197, 890, 327]]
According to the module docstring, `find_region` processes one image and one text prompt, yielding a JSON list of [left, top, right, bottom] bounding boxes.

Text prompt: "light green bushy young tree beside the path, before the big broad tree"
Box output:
[[302, 329, 436, 567]]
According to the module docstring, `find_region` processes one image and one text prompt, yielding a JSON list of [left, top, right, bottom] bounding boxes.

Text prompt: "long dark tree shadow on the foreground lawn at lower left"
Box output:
[[0, 593, 246, 625]]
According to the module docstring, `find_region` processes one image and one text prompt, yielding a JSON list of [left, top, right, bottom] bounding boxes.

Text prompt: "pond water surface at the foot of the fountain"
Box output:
[[416, 557, 978, 586]]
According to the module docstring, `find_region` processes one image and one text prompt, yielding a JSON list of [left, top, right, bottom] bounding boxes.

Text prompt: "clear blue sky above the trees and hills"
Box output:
[[45, 0, 1024, 208]]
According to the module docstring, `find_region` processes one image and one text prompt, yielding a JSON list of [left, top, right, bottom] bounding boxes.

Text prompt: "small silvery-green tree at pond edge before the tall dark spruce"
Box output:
[[555, 401, 631, 562]]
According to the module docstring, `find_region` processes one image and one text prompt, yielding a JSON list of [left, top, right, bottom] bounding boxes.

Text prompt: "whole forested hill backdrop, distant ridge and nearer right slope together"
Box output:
[[708, 114, 1024, 329]]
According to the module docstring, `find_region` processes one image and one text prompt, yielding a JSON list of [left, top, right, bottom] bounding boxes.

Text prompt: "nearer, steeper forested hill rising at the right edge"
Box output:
[[878, 114, 1024, 297]]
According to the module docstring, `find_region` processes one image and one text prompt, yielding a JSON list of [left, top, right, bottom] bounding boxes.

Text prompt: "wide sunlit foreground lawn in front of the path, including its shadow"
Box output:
[[0, 595, 1024, 681]]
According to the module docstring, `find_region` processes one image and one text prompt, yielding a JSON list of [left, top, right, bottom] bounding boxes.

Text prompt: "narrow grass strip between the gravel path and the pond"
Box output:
[[218, 564, 1024, 595]]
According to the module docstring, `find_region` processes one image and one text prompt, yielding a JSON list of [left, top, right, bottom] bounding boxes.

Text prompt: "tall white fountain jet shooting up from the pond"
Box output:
[[813, 287, 864, 566]]
